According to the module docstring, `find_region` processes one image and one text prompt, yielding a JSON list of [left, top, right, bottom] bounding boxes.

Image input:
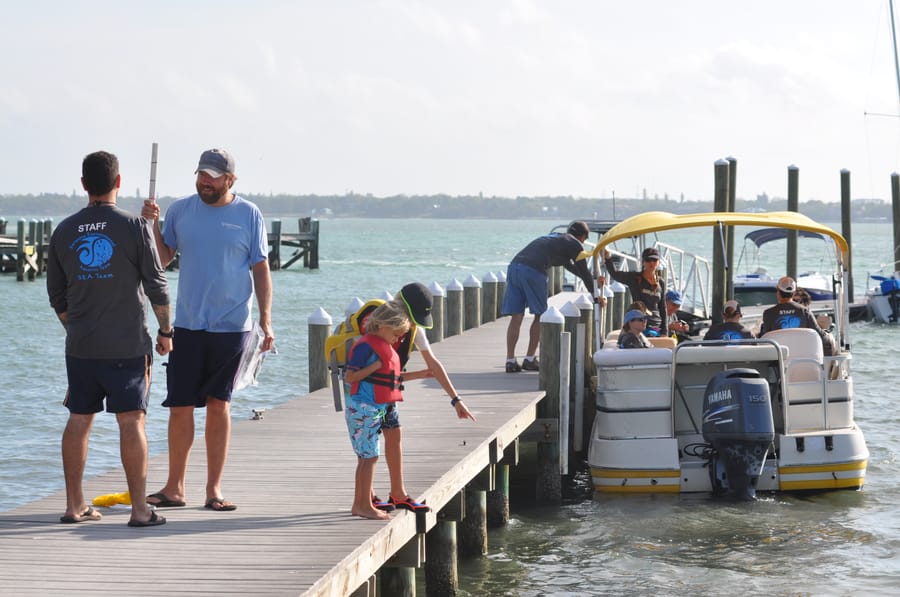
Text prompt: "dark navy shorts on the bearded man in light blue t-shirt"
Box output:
[[163, 328, 250, 408]]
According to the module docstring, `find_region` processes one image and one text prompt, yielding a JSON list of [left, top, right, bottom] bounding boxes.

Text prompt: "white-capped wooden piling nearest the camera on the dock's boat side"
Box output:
[[535, 307, 565, 505]]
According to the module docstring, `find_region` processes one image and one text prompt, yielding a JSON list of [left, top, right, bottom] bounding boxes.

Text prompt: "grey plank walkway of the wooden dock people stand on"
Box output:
[[0, 319, 544, 597]]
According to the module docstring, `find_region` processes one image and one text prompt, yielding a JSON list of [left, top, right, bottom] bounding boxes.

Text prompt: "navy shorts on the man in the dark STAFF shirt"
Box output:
[[63, 354, 153, 415]]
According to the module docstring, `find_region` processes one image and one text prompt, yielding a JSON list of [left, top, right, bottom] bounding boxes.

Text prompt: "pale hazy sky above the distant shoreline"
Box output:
[[0, 0, 900, 201]]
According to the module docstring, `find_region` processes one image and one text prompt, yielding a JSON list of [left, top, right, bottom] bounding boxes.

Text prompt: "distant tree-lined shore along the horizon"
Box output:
[[0, 193, 891, 222]]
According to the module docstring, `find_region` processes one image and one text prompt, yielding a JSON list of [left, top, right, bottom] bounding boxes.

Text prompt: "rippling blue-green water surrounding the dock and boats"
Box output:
[[0, 219, 900, 596]]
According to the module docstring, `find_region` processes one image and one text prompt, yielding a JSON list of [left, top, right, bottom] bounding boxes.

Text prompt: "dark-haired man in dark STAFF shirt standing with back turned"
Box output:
[[47, 151, 172, 527]]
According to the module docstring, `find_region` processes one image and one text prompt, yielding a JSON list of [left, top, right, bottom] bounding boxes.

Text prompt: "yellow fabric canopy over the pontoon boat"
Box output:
[[591, 211, 849, 263]]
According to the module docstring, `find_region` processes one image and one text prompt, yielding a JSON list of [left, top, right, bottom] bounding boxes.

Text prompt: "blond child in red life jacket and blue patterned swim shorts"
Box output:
[[344, 301, 431, 520]]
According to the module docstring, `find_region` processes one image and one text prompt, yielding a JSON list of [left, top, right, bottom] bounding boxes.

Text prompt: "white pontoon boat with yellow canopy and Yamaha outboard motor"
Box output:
[[588, 212, 869, 499]]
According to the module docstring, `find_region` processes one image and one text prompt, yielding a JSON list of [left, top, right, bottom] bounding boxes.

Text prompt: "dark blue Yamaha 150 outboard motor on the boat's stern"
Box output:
[[703, 369, 775, 500]]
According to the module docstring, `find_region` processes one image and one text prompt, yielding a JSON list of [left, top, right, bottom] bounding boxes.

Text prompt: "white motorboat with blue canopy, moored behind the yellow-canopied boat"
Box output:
[[734, 228, 834, 305]]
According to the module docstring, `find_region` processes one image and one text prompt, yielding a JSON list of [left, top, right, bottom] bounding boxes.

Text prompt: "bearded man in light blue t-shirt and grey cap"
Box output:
[[141, 149, 275, 511]]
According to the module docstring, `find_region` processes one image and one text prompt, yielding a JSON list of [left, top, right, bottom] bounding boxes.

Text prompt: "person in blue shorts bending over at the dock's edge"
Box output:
[[501, 222, 598, 373]]
